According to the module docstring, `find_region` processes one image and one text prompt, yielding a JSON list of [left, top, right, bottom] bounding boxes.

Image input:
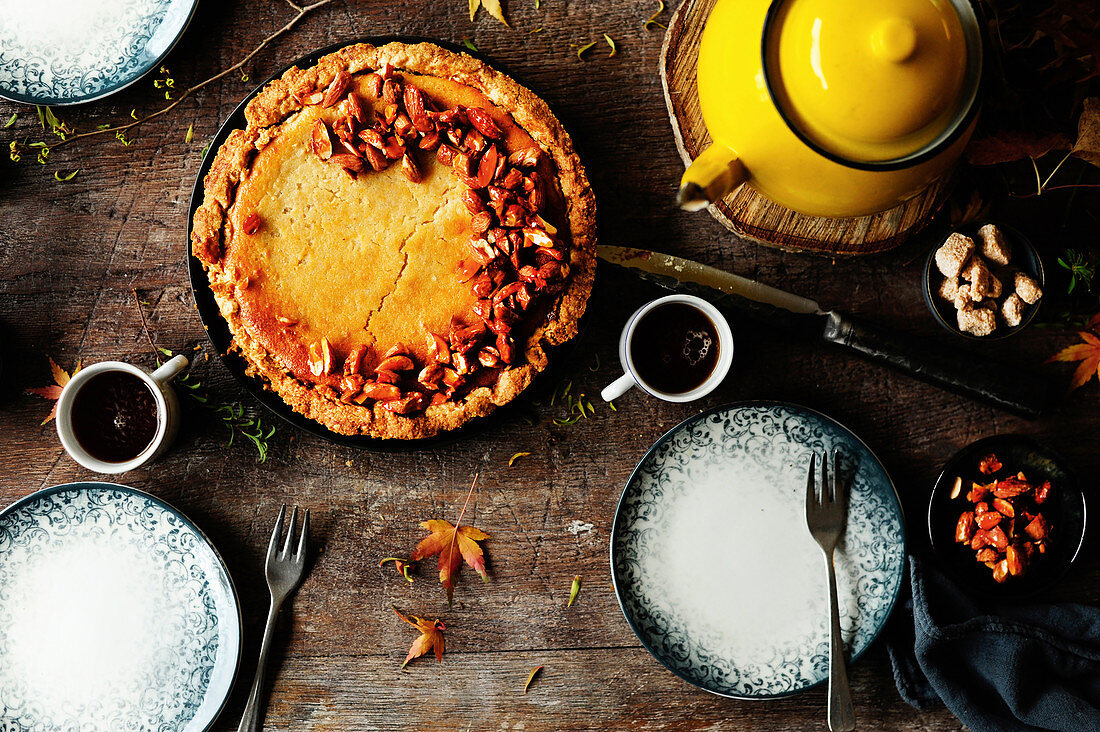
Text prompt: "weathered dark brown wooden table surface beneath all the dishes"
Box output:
[[0, 0, 1100, 732]]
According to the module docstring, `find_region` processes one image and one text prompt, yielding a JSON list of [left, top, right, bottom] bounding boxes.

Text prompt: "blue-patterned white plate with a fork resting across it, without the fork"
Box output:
[[612, 402, 905, 699]]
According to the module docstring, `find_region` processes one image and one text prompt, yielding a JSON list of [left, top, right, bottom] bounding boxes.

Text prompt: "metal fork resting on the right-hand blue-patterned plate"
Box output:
[[806, 450, 856, 732]]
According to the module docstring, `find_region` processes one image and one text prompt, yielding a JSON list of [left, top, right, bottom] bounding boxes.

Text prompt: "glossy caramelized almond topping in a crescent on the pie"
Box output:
[[294, 69, 569, 415]]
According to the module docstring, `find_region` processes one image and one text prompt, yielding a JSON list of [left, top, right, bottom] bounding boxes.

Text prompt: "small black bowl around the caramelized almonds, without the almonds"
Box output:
[[928, 435, 1087, 598]]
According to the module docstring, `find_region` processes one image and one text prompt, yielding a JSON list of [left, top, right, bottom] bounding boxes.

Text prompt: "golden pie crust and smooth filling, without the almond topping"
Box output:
[[191, 43, 595, 439]]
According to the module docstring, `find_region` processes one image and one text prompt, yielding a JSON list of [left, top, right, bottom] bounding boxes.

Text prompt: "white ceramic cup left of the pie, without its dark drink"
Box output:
[[57, 356, 187, 473]]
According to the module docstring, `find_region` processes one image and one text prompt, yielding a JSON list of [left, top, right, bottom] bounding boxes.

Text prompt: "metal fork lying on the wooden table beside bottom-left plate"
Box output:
[[237, 503, 309, 732]]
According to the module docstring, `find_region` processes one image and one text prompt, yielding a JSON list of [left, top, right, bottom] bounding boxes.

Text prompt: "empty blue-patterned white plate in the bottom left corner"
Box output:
[[0, 483, 241, 732]]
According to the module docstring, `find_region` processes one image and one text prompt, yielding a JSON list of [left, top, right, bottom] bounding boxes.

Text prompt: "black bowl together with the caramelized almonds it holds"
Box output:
[[928, 435, 1086, 597]]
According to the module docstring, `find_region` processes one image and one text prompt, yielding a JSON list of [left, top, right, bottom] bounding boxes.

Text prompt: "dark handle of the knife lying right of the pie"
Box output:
[[823, 313, 1052, 419]]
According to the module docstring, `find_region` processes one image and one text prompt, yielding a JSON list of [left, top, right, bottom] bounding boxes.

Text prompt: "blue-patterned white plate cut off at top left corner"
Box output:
[[0, 0, 198, 105]]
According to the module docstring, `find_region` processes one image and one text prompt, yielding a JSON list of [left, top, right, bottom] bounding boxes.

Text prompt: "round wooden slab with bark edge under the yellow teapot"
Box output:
[[660, 0, 949, 255]]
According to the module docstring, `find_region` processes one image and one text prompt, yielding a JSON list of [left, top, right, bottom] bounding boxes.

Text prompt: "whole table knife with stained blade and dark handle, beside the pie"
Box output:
[[597, 244, 1052, 419]]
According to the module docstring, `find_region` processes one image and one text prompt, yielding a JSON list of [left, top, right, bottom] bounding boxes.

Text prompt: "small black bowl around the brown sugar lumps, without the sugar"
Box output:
[[921, 221, 1046, 340]]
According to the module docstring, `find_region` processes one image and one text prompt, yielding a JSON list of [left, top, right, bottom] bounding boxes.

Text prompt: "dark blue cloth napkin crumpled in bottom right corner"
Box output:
[[887, 557, 1100, 732]]
